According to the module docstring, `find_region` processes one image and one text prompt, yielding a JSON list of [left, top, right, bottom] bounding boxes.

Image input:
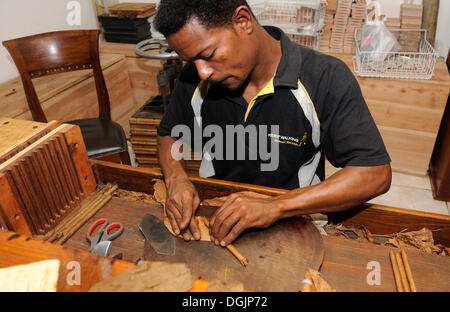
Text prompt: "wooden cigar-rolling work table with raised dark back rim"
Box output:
[[0, 161, 450, 291]]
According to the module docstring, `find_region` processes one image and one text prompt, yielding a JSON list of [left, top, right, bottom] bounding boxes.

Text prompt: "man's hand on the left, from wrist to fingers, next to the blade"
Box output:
[[166, 176, 200, 241]]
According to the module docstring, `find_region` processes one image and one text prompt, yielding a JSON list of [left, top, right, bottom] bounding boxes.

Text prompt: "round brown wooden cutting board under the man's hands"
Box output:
[[144, 206, 324, 292]]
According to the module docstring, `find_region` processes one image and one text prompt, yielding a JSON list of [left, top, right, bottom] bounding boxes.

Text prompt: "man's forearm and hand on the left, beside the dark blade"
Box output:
[[158, 136, 200, 240]]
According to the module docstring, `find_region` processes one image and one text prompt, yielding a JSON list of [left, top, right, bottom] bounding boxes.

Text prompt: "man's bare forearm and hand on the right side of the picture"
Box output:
[[210, 164, 391, 246]]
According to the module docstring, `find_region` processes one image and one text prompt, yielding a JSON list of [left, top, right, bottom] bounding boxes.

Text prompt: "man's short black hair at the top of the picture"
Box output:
[[154, 0, 250, 38]]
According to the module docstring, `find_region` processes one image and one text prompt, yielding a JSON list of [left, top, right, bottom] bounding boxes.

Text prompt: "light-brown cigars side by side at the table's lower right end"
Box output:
[[389, 249, 417, 292]]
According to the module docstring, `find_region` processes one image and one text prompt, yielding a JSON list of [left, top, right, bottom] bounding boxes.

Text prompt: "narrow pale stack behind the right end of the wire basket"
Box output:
[[398, 3, 423, 52]]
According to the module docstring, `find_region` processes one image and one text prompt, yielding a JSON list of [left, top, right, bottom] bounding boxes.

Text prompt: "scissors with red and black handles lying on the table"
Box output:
[[86, 219, 123, 256]]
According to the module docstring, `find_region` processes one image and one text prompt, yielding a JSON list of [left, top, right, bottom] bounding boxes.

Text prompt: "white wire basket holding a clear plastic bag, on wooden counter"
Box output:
[[353, 28, 439, 79]]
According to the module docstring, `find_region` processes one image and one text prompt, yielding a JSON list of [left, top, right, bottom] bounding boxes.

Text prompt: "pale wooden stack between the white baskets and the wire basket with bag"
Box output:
[[320, 0, 366, 53]]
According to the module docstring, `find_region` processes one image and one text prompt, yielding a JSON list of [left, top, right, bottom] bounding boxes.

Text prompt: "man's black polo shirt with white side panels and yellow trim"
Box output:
[[158, 27, 390, 189]]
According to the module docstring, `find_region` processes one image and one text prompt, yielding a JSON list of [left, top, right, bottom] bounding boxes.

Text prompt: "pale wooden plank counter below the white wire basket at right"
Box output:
[[334, 54, 450, 176]]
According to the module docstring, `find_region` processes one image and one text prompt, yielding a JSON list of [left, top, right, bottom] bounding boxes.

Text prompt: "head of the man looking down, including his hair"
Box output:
[[155, 0, 259, 89]]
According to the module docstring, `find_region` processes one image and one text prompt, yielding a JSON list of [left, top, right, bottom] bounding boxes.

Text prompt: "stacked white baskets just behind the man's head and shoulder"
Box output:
[[250, 0, 327, 37]]
